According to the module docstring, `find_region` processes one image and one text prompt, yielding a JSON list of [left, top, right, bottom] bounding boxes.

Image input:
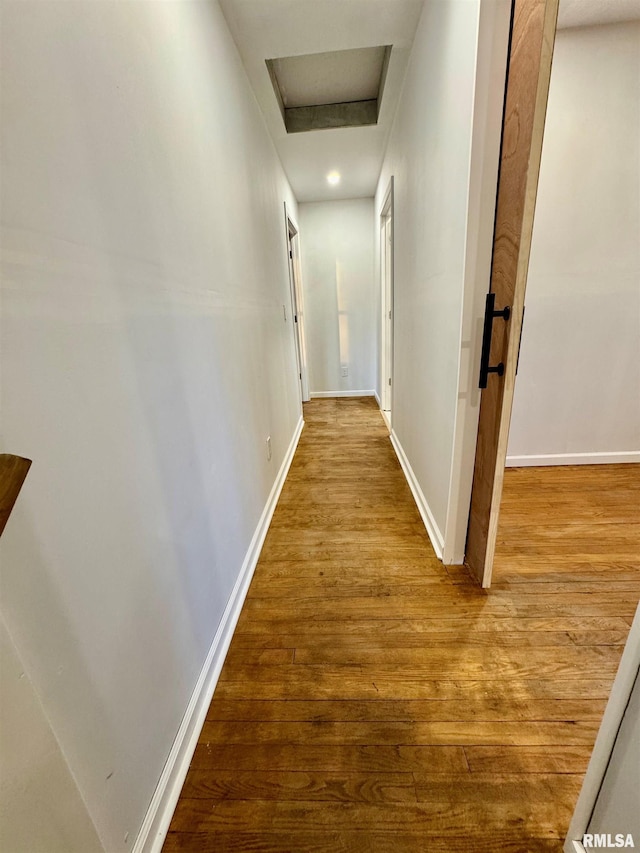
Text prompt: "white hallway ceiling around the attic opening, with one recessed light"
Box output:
[[220, 0, 423, 201]]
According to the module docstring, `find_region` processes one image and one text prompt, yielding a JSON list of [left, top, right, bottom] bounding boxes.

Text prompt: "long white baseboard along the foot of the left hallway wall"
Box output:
[[132, 418, 304, 853]]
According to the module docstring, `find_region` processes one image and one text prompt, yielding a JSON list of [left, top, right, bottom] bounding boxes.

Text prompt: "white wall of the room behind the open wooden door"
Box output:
[[508, 22, 640, 464]]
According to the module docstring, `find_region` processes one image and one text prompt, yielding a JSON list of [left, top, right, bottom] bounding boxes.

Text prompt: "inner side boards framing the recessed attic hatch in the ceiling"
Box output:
[[265, 44, 393, 133]]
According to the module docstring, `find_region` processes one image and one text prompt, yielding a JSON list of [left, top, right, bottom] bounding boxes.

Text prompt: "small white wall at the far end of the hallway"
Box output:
[[298, 198, 377, 395]]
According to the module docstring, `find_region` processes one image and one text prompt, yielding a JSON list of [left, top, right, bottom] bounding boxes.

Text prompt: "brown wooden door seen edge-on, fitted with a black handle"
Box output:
[[465, 0, 559, 589]]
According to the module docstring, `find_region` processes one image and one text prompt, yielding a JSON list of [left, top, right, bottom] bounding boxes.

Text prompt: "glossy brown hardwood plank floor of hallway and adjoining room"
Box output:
[[164, 398, 640, 853]]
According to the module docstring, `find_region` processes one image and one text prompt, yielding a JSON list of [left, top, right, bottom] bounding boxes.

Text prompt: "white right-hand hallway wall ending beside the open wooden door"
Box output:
[[375, 0, 509, 562]]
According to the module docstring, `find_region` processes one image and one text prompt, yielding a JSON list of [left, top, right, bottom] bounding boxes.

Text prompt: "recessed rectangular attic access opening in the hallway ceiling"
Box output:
[[266, 45, 391, 133]]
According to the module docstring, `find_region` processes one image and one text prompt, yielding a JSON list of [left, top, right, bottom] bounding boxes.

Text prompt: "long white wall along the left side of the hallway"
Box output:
[[1, 0, 300, 853]]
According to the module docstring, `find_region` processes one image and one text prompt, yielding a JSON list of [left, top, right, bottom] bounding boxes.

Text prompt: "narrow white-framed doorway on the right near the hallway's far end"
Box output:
[[380, 177, 393, 429]]
